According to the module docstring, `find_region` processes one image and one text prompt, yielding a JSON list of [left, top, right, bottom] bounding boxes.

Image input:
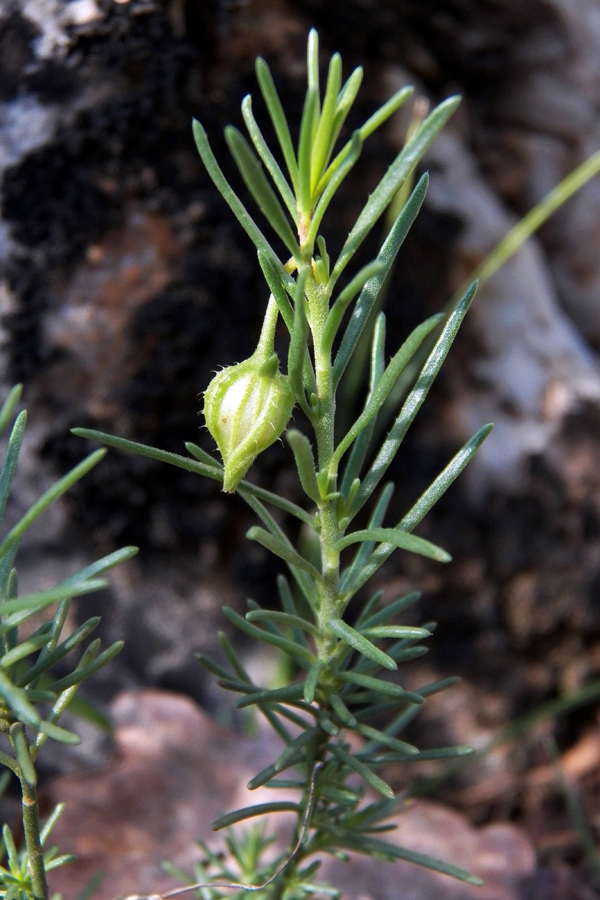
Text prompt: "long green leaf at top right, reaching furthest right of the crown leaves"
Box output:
[[332, 97, 460, 281]]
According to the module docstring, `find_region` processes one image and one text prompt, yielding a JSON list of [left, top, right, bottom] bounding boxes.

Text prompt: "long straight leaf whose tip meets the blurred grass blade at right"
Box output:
[[352, 284, 477, 515]]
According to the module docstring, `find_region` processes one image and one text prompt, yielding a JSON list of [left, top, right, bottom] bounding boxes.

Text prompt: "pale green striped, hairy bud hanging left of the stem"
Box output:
[[204, 351, 294, 492]]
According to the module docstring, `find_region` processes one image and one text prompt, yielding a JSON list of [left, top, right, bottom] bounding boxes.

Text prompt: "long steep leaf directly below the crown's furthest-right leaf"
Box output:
[[333, 174, 429, 386]]
